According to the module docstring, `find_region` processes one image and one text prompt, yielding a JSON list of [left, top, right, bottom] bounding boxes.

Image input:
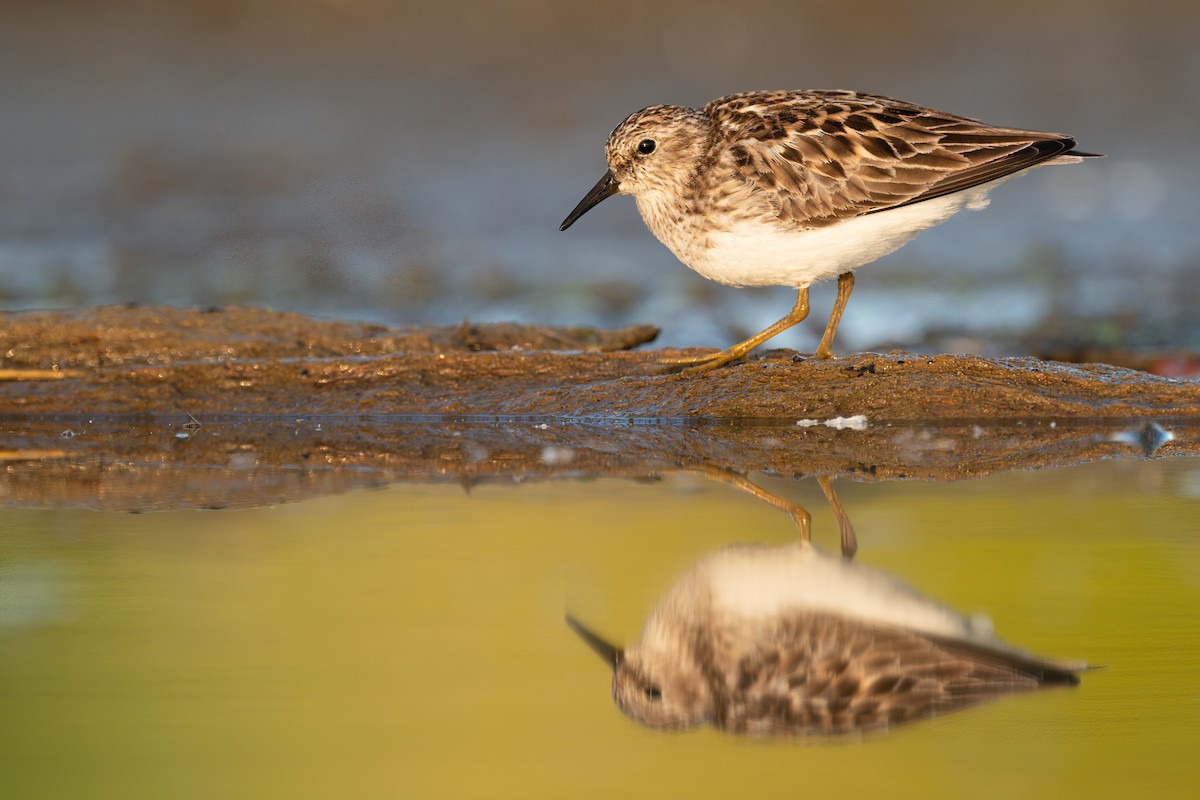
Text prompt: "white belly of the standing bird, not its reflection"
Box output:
[[672, 186, 990, 288]]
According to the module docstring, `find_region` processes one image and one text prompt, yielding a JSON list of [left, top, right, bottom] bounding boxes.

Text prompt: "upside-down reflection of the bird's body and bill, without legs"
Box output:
[[568, 542, 1085, 735]]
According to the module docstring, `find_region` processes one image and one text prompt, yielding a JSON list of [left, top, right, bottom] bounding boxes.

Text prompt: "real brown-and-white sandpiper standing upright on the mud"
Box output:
[[559, 91, 1090, 372]]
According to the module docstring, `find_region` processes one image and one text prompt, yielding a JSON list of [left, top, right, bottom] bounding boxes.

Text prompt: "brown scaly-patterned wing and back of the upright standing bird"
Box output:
[[704, 91, 1082, 228]]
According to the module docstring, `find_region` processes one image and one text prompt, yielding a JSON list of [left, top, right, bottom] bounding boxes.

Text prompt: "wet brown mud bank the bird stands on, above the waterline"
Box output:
[[0, 307, 1200, 423]]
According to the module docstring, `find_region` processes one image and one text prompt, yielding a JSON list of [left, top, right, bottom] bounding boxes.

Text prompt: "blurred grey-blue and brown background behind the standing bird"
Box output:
[[0, 0, 1200, 351]]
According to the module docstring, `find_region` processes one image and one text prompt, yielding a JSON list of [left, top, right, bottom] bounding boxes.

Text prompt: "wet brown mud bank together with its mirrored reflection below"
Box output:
[[0, 307, 1200, 511]]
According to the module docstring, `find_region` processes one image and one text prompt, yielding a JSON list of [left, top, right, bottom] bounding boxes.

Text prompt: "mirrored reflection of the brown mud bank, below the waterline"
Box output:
[[0, 416, 1200, 511]]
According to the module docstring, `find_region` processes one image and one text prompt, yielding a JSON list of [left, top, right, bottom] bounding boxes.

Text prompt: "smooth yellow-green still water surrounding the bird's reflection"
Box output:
[[0, 434, 1200, 798]]
